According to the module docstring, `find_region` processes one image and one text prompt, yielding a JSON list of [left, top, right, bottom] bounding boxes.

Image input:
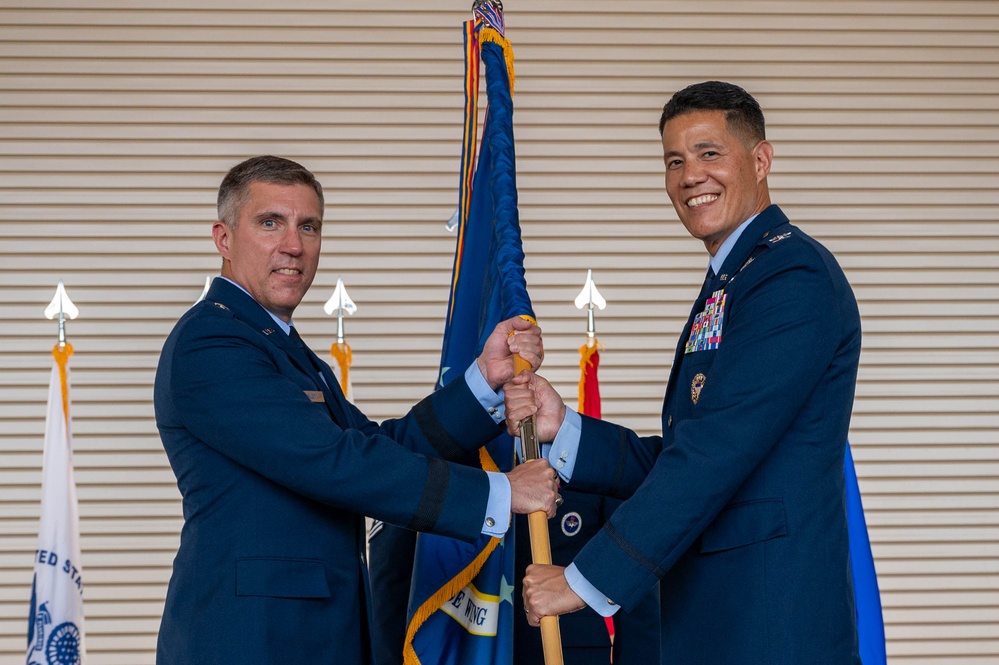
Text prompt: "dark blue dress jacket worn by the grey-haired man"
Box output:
[[154, 279, 502, 665]]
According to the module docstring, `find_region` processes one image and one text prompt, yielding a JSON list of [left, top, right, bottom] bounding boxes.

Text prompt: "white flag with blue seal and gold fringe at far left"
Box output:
[[25, 344, 85, 665]]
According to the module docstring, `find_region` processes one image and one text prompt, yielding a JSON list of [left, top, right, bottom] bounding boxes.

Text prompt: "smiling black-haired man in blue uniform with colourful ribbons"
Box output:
[[505, 81, 861, 665]]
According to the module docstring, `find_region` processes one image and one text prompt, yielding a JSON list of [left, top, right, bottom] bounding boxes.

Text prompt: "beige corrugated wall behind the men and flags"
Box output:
[[0, 0, 999, 665]]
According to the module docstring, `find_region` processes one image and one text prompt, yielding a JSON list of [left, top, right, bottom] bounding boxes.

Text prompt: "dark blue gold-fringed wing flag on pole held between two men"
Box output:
[[403, 18, 534, 665]]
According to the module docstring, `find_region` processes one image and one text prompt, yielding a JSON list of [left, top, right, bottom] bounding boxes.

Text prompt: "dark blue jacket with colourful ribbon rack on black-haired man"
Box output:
[[569, 206, 861, 665]]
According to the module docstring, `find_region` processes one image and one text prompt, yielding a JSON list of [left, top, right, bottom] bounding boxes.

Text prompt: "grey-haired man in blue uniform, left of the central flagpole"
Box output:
[[154, 156, 557, 665]]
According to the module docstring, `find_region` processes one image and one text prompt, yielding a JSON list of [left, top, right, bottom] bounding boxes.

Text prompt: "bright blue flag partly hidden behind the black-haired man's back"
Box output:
[[843, 441, 887, 665]]
